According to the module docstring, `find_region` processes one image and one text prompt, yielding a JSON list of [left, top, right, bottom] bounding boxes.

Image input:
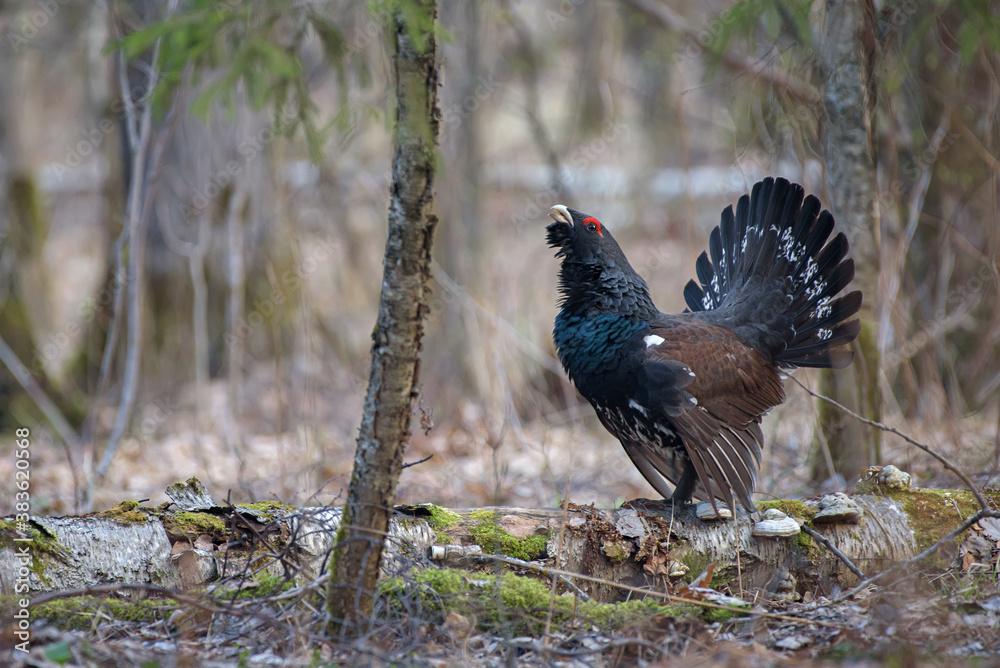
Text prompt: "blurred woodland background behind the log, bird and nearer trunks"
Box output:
[[0, 0, 1000, 514]]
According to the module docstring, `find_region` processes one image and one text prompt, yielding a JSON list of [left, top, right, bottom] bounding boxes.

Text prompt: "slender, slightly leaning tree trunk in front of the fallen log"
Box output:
[[328, 0, 440, 633]]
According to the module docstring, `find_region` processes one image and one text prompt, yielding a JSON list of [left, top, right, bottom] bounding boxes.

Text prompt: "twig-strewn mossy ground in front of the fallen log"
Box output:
[[4, 560, 1000, 668]]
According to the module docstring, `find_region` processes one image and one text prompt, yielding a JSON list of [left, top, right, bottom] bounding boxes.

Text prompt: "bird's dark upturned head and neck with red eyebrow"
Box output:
[[547, 204, 655, 314]]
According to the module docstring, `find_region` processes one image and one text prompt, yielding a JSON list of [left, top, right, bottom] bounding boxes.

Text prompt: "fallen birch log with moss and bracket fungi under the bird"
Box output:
[[0, 480, 984, 601]]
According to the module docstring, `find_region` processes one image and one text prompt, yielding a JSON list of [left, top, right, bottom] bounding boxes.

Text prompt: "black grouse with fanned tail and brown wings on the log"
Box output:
[[547, 178, 861, 511]]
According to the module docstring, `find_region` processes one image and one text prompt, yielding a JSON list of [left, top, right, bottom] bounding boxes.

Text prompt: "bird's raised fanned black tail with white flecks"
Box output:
[[684, 178, 861, 368]]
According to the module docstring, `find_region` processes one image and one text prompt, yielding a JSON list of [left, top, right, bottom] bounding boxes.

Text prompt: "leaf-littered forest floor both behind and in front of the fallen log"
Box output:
[[0, 368, 1000, 666]]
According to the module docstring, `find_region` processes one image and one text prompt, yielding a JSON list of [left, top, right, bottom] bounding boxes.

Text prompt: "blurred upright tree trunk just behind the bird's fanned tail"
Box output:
[[812, 0, 882, 483]]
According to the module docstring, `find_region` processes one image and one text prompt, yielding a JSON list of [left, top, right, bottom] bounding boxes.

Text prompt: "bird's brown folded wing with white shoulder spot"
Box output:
[[644, 319, 785, 509]]
